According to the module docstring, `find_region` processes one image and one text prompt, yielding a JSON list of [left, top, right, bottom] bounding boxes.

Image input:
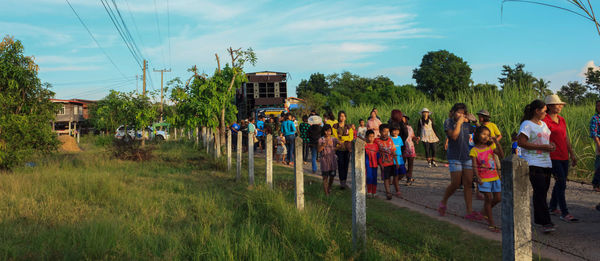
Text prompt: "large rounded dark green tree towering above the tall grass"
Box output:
[[413, 50, 471, 99]]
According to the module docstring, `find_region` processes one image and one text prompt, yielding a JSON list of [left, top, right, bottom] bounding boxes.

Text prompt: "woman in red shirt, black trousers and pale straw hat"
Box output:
[[543, 94, 579, 222]]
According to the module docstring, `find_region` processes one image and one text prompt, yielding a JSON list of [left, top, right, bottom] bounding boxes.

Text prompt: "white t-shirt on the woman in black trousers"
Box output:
[[519, 120, 552, 168]]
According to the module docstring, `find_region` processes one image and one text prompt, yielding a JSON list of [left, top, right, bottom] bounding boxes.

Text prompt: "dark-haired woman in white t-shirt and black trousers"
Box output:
[[517, 100, 555, 233]]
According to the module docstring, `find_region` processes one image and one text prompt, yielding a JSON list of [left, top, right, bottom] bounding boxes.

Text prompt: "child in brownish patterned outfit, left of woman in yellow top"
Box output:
[[318, 124, 341, 196]]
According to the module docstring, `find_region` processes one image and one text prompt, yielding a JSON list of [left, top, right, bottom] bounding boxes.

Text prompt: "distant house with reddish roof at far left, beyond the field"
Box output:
[[50, 99, 95, 135]]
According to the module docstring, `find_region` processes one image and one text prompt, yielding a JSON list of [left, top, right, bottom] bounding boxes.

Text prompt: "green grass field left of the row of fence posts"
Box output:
[[0, 139, 501, 260]]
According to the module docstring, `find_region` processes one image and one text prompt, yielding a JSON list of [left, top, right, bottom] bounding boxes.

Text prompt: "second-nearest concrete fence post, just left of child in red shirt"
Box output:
[[351, 139, 367, 250]]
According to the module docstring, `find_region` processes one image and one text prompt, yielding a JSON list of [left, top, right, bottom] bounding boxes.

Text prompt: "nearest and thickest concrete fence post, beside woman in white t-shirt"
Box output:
[[502, 154, 533, 261]]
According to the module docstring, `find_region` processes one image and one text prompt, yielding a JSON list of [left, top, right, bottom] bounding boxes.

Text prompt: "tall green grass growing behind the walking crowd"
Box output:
[[336, 87, 595, 180]]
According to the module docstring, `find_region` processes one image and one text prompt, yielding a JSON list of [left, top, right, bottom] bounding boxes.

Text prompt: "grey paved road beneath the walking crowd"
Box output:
[[290, 155, 600, 260]]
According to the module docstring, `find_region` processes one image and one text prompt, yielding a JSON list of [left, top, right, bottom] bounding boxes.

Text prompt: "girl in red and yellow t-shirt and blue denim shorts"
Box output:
[[469, 126, 504, 232]]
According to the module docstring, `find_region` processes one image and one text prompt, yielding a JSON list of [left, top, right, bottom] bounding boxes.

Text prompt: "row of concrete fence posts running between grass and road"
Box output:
[[202, 127, 533, 260]]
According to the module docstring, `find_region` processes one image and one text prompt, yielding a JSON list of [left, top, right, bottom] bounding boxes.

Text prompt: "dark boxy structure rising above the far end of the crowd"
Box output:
[[235, 71, 287, 119]]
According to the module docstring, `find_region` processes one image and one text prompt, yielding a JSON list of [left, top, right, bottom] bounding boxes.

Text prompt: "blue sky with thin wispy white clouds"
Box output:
[[0, 0, 600, 99]]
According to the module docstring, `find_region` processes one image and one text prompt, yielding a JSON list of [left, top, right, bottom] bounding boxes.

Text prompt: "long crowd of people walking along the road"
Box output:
[[230, 95, 600, 233]]
